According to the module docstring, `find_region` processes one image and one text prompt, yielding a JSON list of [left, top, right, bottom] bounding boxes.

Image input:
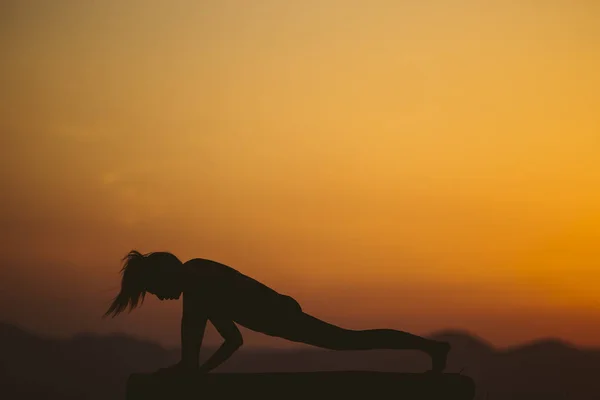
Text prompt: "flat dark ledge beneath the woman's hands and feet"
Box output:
[[127, 371, 475, 400]]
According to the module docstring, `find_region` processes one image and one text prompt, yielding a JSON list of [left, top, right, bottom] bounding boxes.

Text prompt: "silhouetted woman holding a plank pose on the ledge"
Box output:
[[104, 250, 450, 373]]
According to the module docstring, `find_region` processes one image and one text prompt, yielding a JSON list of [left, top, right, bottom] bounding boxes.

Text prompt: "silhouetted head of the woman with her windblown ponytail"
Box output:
[[105, 250, 183, 317]]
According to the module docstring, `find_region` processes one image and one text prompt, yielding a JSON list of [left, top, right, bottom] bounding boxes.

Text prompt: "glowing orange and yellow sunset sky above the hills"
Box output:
[[0, 0, 600, 346]]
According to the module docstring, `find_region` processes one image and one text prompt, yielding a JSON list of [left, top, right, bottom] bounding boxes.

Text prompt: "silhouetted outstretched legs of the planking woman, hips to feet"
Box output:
[[276, 312, 450, 372]]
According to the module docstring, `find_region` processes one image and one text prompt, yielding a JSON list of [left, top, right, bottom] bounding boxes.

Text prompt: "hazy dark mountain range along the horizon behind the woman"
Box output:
[[0, 323, 600, 400]]
